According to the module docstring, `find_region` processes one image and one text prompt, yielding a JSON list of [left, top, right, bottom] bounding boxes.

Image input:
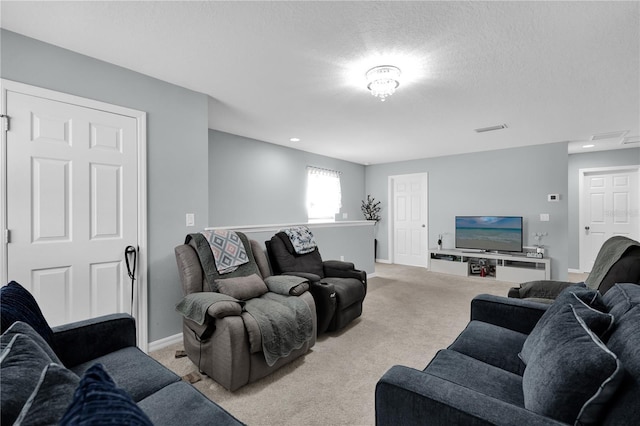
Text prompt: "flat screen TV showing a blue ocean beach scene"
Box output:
[[456, 216, 522, 252]]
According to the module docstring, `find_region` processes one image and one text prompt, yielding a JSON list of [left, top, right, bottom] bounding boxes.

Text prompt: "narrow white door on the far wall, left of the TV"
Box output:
[[392, 173, 428, 268]]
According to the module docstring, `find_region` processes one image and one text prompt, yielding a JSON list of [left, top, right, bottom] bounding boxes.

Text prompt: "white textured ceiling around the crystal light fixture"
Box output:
[[0, 1, 640, 164]]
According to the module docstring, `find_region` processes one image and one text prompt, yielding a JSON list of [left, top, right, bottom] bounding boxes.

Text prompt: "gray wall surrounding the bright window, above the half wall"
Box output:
[[209, 130, 365, 226]]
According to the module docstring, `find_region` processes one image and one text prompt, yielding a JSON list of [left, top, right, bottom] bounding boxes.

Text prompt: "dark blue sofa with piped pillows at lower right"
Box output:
[[375, 284, 640, 425]]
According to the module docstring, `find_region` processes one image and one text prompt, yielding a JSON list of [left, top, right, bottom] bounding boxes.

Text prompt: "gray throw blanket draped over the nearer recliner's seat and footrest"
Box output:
[[245, 292, 313, 367]]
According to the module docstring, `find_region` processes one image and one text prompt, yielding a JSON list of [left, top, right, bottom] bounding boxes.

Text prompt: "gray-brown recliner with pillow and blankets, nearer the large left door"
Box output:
[[175, 232, 317, 391]]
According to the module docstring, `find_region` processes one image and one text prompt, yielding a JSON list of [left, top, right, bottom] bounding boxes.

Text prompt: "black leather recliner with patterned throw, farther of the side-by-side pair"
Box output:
[[265, 232, 367, 334]]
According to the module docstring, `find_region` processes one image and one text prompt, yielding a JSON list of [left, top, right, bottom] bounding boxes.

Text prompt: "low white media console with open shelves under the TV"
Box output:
[[429, 249, 551, 283]]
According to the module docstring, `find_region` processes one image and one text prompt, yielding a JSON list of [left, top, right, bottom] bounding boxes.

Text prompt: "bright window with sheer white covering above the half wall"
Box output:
[[307, 167, 342, 221]]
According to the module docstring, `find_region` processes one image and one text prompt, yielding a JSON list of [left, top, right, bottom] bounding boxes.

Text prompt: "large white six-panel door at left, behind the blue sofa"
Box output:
[[2, 81, 147, 347]]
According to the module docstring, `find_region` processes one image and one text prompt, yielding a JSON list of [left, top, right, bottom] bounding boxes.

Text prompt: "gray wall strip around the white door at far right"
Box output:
[[569, 148, 640, 270]]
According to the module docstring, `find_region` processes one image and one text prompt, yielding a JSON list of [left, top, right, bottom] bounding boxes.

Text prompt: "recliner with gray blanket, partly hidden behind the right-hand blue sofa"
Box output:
[[508, 236, 640, 303]]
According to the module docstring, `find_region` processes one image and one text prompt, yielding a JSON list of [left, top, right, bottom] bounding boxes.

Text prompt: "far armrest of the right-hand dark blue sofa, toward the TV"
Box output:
[[471, 294, 549, 334]]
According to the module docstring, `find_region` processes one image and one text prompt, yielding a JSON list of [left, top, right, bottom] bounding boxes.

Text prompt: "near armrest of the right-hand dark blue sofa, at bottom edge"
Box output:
[[375, 365, 563, 426]]
